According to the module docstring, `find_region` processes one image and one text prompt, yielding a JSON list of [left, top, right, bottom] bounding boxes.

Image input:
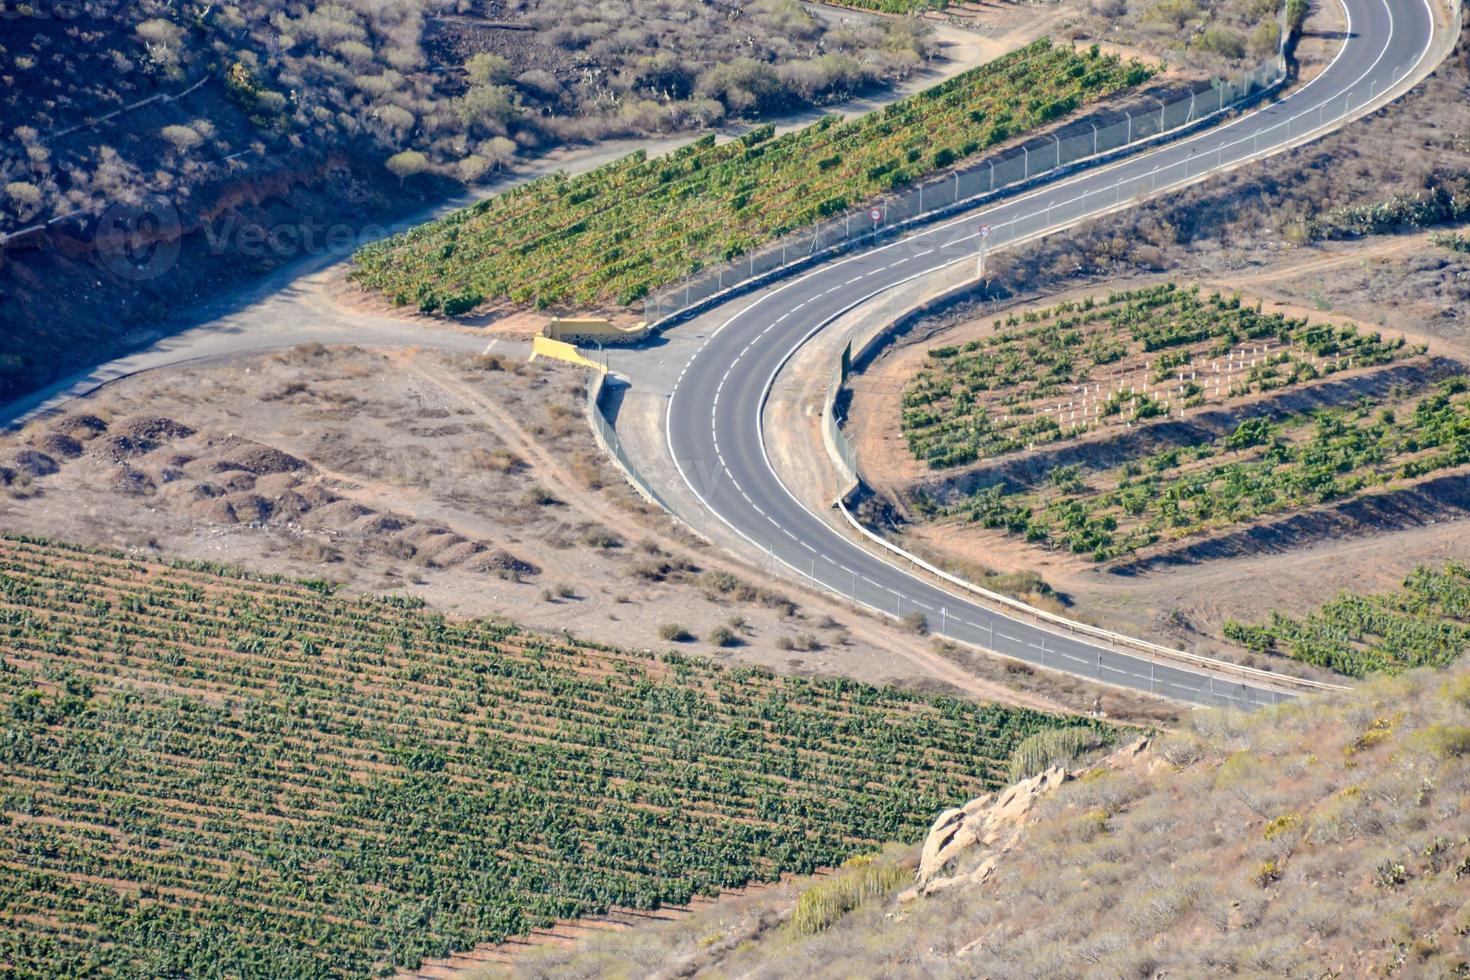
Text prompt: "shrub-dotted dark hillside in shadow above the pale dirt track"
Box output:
[[0, 0, 936, 403]]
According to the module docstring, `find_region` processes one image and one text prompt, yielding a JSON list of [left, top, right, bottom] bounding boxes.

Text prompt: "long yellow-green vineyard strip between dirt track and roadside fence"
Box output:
[[353, 40, 1155, 311]]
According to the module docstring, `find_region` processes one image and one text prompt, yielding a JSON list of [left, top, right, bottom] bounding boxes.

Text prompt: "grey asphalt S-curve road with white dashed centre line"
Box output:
[[664, 0, 1433, 708]]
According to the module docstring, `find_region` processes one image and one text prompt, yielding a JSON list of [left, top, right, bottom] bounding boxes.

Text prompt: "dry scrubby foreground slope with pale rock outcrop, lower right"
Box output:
[[515, 667, 1470, 977]]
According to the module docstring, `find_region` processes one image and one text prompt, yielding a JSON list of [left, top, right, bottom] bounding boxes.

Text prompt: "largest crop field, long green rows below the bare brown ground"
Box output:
[[0, 538, 1087, 979]]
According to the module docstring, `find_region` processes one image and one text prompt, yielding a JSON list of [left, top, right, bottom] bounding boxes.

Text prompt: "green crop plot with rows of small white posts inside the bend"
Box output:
[[901, 282, 1423, 470]]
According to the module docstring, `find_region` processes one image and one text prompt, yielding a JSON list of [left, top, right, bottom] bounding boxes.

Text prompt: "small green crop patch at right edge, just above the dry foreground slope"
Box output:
[[1225, 563, 1470, 677]]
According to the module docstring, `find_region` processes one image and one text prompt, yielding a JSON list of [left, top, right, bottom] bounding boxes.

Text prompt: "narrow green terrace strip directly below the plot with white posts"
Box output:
[[917, 378, 1470, 561]]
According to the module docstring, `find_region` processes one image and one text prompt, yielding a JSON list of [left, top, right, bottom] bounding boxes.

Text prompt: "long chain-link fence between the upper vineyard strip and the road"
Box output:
[[644, 59, 1286, 323]]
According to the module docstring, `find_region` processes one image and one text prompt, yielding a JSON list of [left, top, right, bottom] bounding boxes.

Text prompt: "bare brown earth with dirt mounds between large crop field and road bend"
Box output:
[[0, 345, 1105, 718]]
